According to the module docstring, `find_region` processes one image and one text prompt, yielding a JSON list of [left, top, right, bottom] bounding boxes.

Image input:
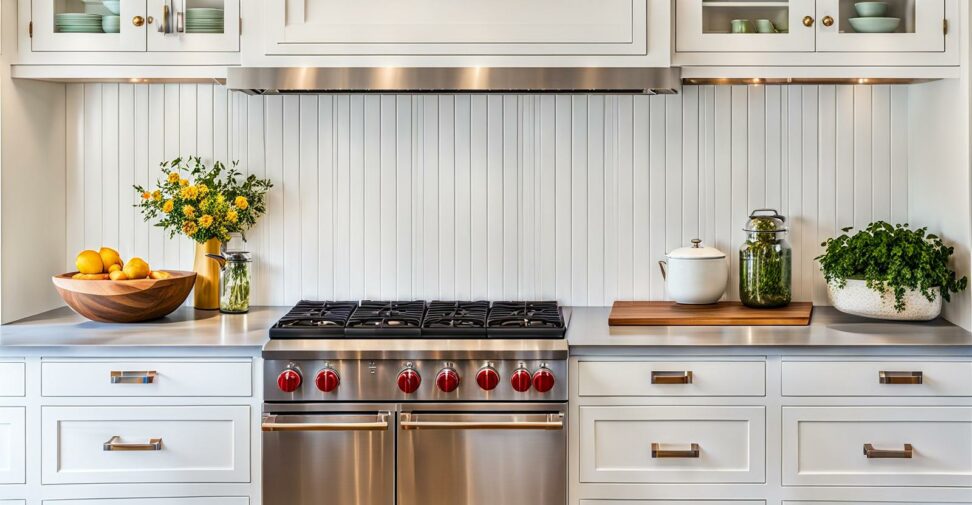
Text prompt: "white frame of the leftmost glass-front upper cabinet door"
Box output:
[[30, 0, 149, 52]]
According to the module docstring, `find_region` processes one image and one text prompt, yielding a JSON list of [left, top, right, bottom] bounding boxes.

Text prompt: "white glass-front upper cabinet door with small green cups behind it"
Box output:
[[675, 0, 816, 52]]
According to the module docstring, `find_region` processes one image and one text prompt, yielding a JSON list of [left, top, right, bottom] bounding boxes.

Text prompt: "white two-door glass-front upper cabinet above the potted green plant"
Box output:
[[675, 0, 960, 67]]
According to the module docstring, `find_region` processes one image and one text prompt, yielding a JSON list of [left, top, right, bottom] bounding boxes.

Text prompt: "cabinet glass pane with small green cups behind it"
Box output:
[[702, 0, 791, 35]]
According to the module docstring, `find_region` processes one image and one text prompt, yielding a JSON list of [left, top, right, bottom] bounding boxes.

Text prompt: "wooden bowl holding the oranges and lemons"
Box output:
[[53, 270, 196, 323]]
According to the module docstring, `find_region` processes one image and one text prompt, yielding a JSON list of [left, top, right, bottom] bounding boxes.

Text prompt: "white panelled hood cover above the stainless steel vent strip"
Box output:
[[264, 0, 652, 56]]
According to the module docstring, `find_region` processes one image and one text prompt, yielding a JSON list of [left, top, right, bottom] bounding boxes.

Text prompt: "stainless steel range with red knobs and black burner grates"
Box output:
[[263, 301, 567, 505]]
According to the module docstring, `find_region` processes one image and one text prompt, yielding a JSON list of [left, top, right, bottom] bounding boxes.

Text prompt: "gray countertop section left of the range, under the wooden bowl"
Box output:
[[0, 307, 288, 349]]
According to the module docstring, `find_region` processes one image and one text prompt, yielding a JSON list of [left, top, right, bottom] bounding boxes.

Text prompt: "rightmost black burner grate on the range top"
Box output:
[[486, 301, 565, 338]]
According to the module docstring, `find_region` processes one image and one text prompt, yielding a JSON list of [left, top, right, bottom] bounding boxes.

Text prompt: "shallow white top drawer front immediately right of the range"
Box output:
[[577, 361, 766, 396]]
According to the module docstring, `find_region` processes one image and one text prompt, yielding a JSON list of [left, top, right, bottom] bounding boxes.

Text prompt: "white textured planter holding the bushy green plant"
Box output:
[[827, 279, 942, 321]]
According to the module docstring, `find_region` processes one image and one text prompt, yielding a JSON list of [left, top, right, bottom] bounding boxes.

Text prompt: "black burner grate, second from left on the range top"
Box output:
[[345, 300, 425, 338]]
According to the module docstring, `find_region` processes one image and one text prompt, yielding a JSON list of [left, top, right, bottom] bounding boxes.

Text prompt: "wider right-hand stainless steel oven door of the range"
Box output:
[[397, 404, 567, 505]]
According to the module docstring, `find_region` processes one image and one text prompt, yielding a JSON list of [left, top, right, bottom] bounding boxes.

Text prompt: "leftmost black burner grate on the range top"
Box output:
[[270, 300, 358, 338]]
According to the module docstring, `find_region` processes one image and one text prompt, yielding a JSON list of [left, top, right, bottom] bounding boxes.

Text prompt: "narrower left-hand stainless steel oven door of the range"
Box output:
[[262, 405, 395, 505]]
